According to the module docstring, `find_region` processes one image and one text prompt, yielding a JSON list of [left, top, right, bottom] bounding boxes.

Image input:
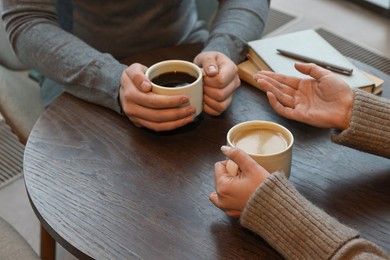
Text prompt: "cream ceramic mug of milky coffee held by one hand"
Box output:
[[227, 120, 294, 178]]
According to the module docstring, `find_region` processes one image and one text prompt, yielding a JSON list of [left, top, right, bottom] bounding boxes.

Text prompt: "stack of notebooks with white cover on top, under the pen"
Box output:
[[238, 30, 384, 94]]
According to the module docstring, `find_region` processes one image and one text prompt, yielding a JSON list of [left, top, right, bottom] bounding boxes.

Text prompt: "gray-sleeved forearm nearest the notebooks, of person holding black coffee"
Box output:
[[204, 0, 269, 63]]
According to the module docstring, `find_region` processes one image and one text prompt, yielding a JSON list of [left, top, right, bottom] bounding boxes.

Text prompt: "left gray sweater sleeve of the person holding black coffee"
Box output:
[[2, 0, 127, 112]]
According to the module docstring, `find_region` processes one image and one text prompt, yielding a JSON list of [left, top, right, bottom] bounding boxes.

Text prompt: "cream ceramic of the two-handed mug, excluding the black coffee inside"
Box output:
[[145, 60, 203, 116]]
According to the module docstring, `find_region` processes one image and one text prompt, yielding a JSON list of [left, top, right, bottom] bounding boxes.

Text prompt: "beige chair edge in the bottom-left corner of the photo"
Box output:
[[0, 217, 39, 260]]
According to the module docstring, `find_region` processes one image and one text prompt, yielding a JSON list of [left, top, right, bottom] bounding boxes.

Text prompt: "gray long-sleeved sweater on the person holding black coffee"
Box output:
[[2, 0, 269, 112]]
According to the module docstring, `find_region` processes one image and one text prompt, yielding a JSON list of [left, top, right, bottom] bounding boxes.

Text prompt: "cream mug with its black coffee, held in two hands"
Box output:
[[145, 60, 203, 117]]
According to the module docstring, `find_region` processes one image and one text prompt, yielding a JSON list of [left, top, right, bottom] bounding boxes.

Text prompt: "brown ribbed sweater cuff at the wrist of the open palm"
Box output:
[[332, 90, 390, 158]]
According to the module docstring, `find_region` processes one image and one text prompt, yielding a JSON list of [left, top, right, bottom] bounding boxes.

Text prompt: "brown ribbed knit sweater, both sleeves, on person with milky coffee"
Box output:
[[241, 90, 390, 259]]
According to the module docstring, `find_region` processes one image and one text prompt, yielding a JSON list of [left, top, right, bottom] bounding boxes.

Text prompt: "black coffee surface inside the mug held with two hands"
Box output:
[[152, 71, 196, 88]]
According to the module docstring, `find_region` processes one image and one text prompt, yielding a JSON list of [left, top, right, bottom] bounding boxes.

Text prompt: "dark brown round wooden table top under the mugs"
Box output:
[[24, 45, 390, 259]]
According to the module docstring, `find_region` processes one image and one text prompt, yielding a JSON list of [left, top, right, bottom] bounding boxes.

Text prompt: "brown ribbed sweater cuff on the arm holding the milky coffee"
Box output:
[[240, 173, 358, 259]]
